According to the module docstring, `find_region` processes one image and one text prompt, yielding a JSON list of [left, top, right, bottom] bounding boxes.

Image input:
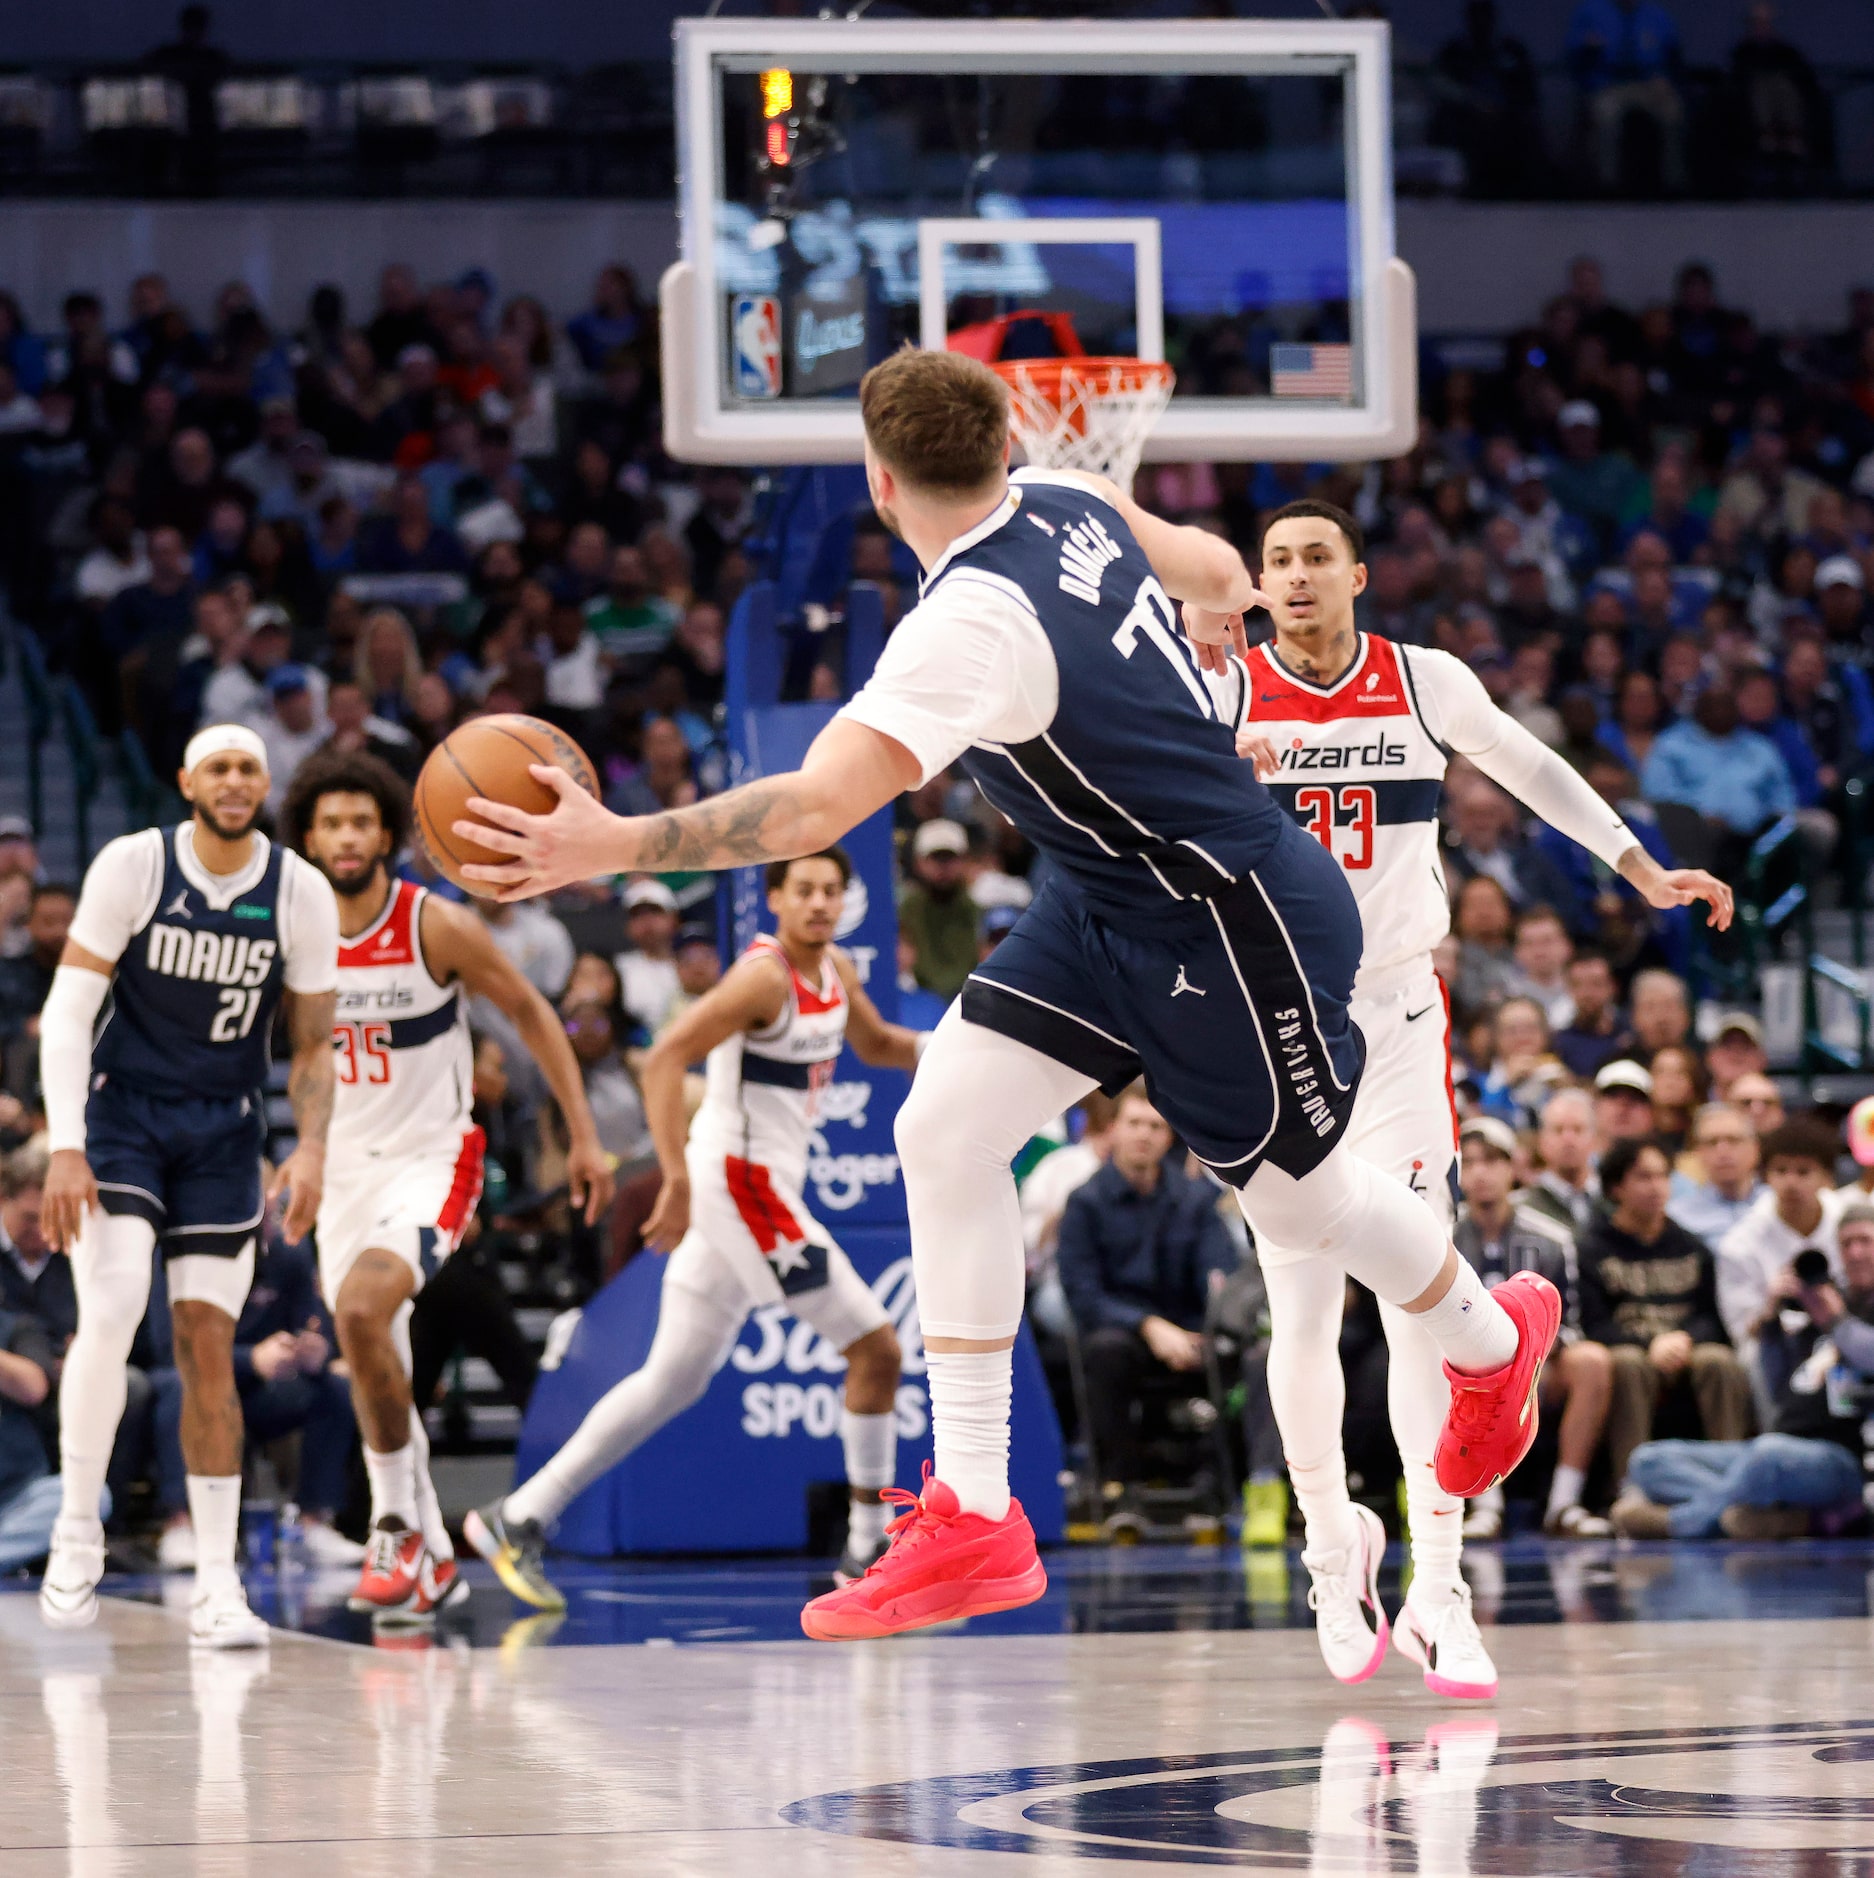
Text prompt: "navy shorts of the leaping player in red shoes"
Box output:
[[963, 819, 1365, 1187]]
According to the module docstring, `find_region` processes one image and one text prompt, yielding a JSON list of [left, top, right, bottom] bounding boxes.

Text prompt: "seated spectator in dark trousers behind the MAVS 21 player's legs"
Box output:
[[150, 1232, 364, 1572]]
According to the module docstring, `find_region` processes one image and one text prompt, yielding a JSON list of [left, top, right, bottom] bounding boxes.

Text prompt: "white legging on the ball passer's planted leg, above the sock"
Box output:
[[896, 1005, 1095, 1343]]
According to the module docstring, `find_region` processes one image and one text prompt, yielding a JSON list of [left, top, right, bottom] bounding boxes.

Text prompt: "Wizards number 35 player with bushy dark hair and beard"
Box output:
[[282, 753, 612, 1624]]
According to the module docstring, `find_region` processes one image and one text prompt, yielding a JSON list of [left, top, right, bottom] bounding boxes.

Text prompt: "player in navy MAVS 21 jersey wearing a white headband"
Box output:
[[39, 725, 338, 1649]]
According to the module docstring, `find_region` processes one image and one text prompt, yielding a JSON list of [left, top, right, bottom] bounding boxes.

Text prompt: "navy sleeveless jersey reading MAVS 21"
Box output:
[[92, 824, 285, 1101]]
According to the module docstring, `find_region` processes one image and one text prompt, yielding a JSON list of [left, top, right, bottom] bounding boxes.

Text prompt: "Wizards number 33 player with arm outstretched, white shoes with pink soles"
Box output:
[[1232, 501, 1731, 1698]]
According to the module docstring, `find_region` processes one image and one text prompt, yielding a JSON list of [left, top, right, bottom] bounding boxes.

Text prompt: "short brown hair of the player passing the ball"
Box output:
[[858, 346, 1008, 496]]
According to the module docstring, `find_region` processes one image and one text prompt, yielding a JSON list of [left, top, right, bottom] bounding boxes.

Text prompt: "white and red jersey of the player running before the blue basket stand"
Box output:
[[689, 933, 847, 1193]]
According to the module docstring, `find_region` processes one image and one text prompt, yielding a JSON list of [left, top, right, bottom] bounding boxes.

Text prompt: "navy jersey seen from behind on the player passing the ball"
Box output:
[[926, 471, 1283, 926]]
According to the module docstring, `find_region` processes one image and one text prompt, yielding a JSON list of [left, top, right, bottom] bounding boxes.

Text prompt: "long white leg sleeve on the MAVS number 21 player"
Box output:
[[58, 1208, 156, 1521]]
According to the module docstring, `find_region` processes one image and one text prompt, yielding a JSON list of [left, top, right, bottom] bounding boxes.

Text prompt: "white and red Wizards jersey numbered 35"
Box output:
[[330, 881, 475, 1170]]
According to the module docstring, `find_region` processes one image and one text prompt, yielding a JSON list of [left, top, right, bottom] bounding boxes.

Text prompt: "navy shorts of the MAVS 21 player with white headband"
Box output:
[[84, 1078, 267, 1258]]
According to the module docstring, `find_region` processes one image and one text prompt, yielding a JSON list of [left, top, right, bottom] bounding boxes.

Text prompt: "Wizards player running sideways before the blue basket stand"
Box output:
[[464, 849, 920, 1609]]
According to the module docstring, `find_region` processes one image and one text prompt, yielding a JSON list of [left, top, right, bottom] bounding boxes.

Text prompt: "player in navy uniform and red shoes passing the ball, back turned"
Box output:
[[458, 349, 1560, 1638]]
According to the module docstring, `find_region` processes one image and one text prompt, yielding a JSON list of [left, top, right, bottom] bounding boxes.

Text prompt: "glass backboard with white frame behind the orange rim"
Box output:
[[663, 19, 1416, 462]]
